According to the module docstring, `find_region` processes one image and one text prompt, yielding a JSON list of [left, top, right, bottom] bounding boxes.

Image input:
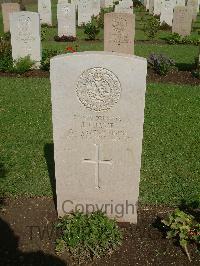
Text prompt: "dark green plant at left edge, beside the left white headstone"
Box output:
[[0, 39, 13, 72]]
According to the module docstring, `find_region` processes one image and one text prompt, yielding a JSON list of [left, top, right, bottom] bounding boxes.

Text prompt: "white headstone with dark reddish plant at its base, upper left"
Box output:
[[57, 3, 76, 37]]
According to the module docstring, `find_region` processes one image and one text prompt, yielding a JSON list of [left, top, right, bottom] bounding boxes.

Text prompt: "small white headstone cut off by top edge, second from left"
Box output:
[[38, 0, 52, 26]]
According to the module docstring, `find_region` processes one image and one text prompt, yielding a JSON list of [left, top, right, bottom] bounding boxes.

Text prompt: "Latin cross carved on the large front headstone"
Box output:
[[83, 144, 112, 189]]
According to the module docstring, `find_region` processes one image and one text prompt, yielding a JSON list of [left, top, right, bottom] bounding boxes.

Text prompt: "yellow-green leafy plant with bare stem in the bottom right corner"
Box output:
[[162, 209, 200, 261]]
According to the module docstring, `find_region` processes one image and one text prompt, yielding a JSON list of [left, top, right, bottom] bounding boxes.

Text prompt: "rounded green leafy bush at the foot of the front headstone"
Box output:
[[56, 212, 122, 260]]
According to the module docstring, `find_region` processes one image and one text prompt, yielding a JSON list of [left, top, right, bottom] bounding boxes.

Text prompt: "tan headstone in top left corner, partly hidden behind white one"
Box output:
[[1, 3, 20, 32]]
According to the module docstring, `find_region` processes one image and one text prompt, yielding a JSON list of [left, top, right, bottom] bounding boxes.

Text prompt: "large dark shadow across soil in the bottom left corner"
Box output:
[[0, 218, 68, 266]]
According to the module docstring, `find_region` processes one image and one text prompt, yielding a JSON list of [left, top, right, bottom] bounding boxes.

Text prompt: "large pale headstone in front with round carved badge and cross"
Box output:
[[51, 52, 147, 223]]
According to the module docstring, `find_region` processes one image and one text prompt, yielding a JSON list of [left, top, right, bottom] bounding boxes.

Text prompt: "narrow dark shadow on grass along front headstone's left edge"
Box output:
[[44, 143, 57, 209]]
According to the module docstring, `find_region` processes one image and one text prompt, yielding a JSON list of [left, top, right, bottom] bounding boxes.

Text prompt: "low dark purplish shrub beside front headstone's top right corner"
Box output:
[[147, 54, 175, 76]]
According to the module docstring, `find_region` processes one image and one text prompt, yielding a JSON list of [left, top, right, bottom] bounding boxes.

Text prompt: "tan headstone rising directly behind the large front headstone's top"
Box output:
[[104, 13, 135, 54]]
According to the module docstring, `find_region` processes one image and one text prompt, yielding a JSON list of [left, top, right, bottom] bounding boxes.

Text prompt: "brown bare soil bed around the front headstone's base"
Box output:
[[0, 197, 200, 266]]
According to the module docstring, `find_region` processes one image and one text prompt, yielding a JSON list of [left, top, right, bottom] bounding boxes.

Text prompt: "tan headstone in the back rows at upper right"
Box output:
[[172, 6, 192, 36]]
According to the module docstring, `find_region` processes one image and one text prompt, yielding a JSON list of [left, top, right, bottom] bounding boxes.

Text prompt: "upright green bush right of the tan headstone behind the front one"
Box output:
[[144, 16, 160, 39]]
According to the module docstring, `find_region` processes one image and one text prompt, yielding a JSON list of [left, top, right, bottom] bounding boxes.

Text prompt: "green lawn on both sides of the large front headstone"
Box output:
[[0, 78, 200, 205]]
